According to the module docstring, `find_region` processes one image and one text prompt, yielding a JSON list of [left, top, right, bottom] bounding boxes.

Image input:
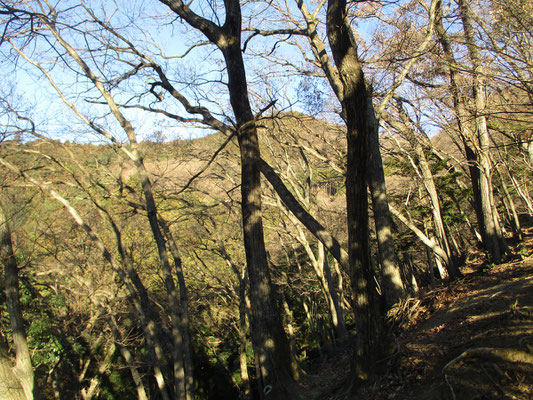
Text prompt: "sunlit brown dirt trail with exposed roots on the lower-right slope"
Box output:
[[390, 257, 533, 400]]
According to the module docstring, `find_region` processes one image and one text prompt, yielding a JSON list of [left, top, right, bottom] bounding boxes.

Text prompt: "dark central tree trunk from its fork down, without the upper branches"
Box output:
[[223, 41, 302, 399]]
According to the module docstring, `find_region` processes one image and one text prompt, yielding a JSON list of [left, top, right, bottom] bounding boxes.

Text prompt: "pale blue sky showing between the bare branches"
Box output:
[[0, 0, 432, 140]]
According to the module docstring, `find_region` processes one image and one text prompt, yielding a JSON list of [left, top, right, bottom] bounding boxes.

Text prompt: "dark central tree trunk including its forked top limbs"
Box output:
[[157, 0, 298, 399]]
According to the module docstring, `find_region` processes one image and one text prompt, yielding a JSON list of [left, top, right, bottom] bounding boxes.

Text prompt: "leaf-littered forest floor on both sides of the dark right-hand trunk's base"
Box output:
[[311, 222, 533, 400]]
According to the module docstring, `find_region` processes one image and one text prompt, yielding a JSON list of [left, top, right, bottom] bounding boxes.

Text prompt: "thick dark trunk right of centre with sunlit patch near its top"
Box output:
[[327, 0, 380, 386]]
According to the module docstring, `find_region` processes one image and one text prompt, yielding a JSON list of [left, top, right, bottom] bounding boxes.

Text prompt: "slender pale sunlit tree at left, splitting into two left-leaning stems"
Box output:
[[3, 1, 194, 399]]
